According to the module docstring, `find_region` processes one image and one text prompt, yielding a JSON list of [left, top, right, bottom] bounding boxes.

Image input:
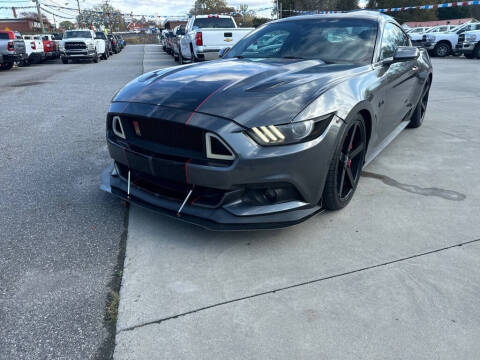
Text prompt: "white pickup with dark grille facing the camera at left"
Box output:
[[60, 29, 106, 64]]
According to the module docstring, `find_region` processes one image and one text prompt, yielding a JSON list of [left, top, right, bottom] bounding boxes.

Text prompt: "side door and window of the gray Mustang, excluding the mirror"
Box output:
[[379, 23, 418, 138]]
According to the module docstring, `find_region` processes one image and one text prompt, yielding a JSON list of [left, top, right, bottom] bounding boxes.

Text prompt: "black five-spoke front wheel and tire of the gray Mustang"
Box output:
[[323, 114, 367, 210]]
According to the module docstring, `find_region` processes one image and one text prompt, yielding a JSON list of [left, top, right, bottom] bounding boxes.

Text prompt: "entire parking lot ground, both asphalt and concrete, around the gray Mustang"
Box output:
[[0, 45, 480, 360]]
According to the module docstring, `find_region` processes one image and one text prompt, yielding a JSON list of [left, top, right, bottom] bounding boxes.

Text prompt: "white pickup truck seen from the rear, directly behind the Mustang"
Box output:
[[179, 15, 253, 64]]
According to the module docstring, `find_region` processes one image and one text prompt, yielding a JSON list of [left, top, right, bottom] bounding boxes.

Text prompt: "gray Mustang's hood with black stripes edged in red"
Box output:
[[113, 59, 366, 126]]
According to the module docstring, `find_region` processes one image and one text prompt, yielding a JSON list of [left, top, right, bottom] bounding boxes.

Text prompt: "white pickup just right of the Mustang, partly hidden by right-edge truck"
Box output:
[[422, 22, 480, 57]]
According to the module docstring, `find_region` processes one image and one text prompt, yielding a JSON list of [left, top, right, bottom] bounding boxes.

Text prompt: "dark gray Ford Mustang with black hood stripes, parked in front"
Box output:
[[102, 11, 432, 229]]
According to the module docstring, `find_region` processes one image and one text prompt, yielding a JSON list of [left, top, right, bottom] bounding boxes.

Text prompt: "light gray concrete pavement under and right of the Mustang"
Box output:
[[114, 54, 480, 360]]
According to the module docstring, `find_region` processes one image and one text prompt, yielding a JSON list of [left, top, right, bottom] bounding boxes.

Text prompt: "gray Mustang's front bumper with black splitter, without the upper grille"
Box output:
[[101, 103, 343, 230]]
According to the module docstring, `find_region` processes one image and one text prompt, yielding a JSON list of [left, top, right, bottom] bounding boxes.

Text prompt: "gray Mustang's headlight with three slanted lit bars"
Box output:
[[247, 114, 333, 146]]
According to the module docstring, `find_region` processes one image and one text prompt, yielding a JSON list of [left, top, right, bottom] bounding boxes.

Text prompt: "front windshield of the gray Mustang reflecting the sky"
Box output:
[[225, 18, 377, 64]]
